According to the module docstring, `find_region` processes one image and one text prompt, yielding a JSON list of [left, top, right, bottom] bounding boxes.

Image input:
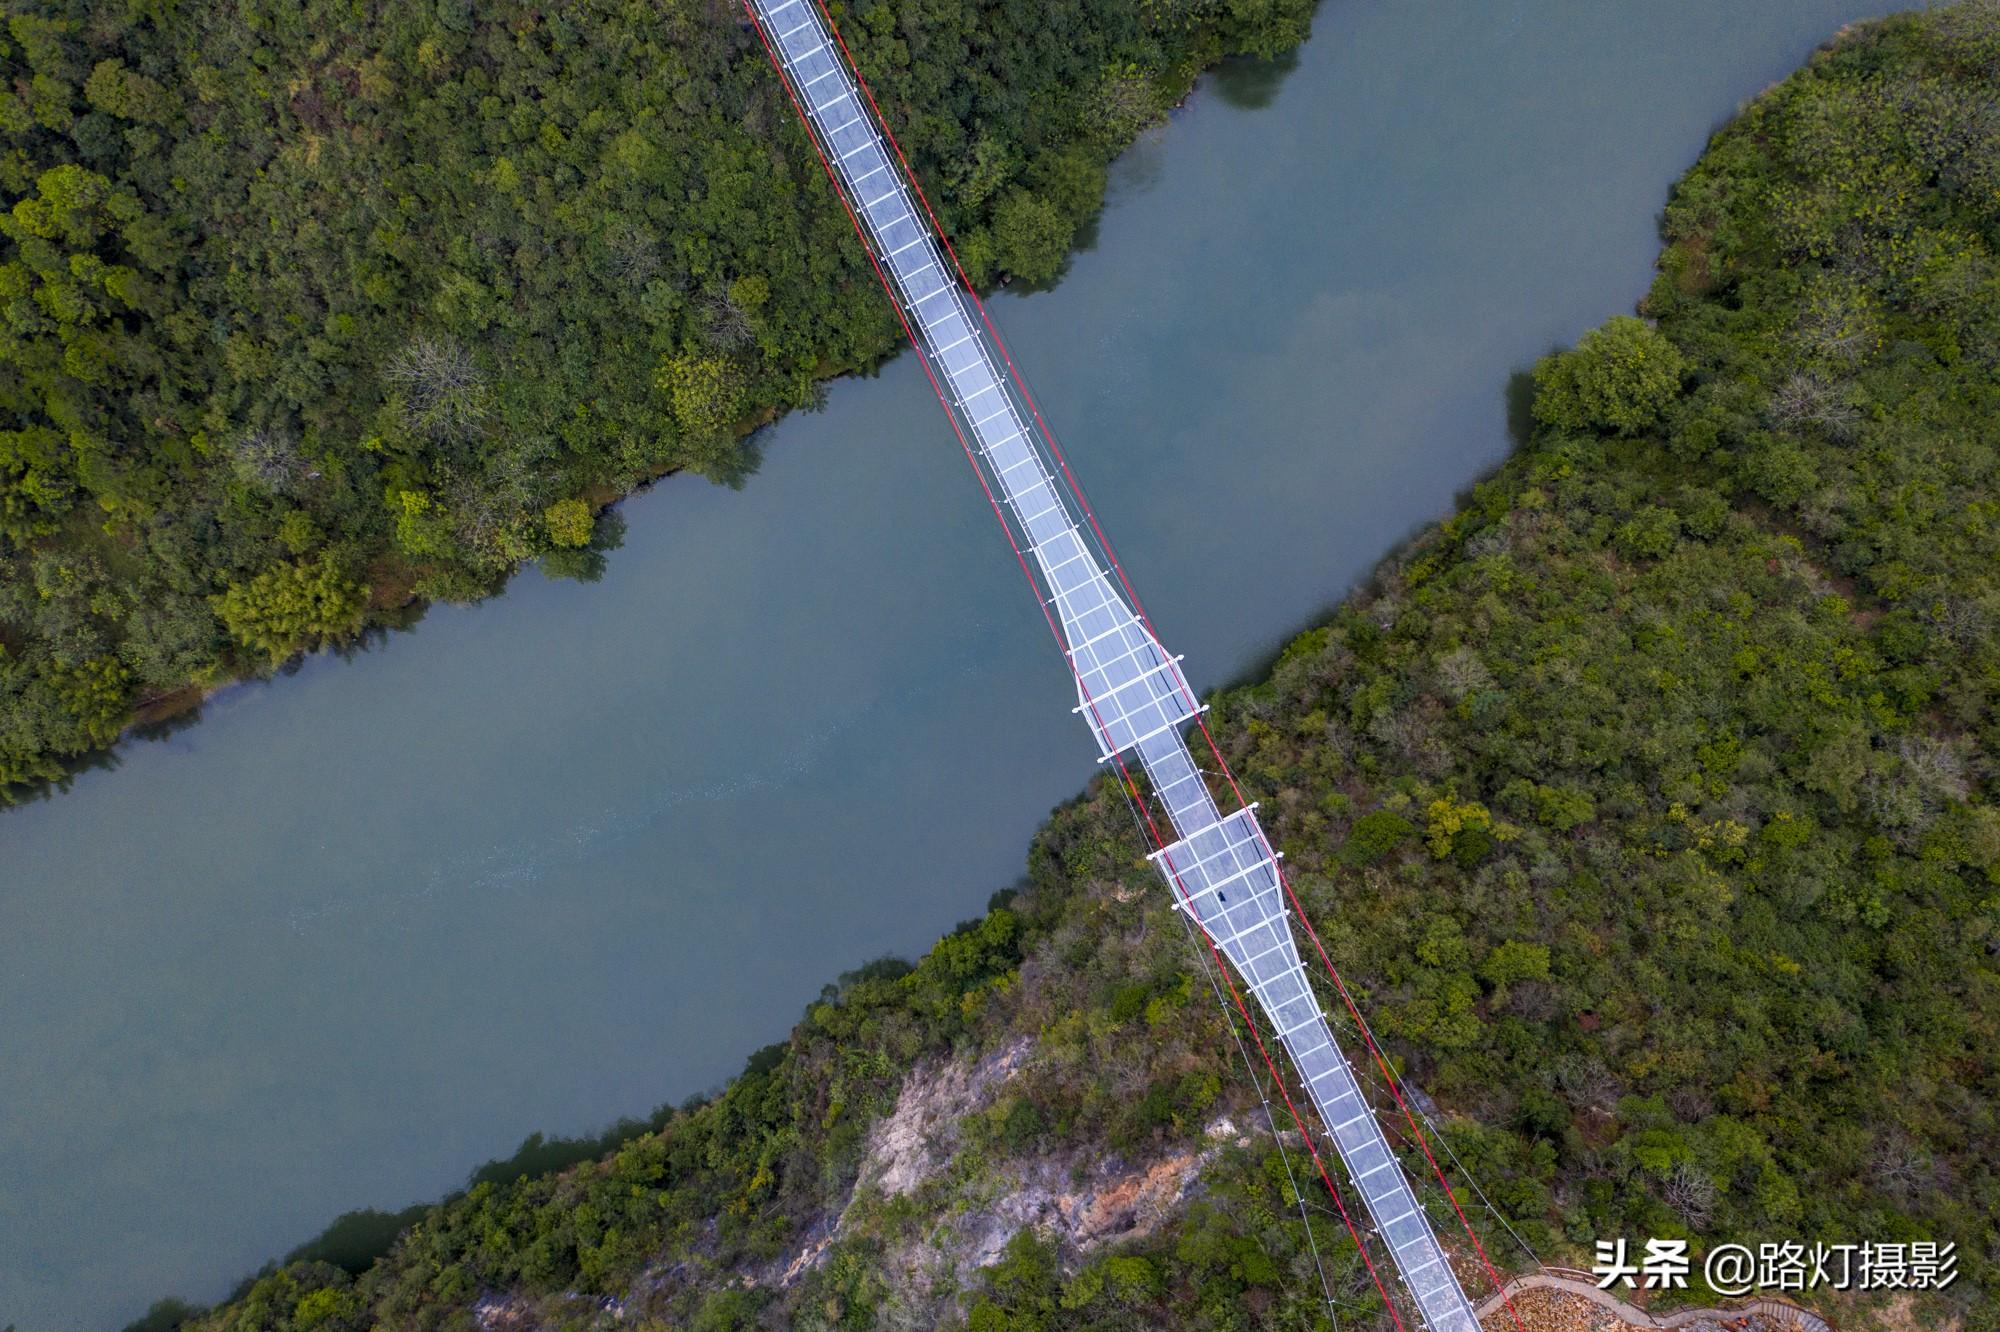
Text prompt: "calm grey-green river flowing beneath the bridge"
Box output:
[[0, 0, 1872, 1332]]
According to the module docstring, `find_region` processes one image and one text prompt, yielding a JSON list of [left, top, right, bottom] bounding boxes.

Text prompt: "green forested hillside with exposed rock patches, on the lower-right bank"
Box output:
[[162, 4, 2000, 1332]]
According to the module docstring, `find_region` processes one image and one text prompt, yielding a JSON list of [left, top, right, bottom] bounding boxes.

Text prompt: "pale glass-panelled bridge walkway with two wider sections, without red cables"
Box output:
[[754, 0, 1478, 1332]]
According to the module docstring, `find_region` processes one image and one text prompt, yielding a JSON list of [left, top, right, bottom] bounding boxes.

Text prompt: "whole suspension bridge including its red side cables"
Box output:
[[744, 0, 1504, 1332]]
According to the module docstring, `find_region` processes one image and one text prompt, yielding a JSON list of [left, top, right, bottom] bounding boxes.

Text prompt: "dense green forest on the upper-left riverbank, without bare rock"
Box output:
[[0, 0, 1310, 802]]
